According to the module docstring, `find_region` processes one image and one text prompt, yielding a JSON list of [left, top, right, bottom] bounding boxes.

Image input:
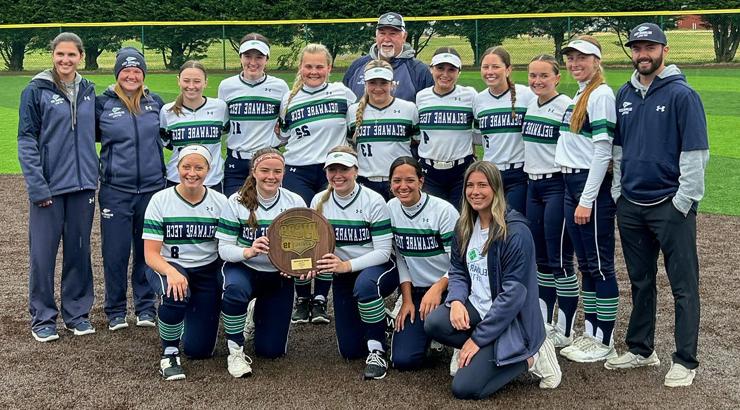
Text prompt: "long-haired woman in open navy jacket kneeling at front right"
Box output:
[[424, 161, 562, 399]]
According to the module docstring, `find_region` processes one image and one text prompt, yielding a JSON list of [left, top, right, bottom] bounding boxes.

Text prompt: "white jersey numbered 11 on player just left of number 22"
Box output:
[[218, 74, 289, 158]]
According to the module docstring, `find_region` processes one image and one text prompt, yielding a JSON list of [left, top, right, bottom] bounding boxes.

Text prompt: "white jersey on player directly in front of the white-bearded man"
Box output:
[[347, 98, 419, 177]]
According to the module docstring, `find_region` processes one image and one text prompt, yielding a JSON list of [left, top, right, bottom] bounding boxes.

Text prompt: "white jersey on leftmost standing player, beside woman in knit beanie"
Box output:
[[159, 97, 229, 186]]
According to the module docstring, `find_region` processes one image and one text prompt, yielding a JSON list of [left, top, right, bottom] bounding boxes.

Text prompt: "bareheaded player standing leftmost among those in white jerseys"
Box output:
[[159, 60, 229, 192]]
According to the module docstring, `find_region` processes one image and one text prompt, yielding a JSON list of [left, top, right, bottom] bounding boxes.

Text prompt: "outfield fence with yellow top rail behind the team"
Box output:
[[0, 9, 740, 71]]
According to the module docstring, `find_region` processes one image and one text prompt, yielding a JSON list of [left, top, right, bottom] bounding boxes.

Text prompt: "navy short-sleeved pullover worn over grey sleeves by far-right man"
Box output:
[[614, 74, 709, 203]]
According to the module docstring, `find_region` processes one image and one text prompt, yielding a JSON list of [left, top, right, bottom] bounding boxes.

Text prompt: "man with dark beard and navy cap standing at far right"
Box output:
[[604, 23, 709, 387]]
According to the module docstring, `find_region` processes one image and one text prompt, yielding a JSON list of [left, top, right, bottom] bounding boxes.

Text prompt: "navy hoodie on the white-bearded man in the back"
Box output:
[[342, 44, 434, 102]]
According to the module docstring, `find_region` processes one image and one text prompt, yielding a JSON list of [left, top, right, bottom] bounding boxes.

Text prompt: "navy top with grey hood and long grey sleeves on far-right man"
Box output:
[[612, 65, 709, 215]]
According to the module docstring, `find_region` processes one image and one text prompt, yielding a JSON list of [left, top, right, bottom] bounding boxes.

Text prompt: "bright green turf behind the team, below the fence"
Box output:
[[0, 68, 740, 215]]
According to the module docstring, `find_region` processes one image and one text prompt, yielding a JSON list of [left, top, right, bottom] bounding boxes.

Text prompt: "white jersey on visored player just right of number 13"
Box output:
[[416, 85, 478, 161]]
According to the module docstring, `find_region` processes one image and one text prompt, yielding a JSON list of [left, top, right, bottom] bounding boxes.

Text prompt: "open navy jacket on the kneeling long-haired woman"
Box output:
[[446, 210, 545, 366]]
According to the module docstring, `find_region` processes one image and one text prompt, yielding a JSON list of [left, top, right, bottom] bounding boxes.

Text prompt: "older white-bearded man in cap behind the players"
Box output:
[[342, 12, 434, 102]]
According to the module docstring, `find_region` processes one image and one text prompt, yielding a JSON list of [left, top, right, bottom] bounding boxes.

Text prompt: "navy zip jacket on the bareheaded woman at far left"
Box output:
[[18, 72, 98, 203]]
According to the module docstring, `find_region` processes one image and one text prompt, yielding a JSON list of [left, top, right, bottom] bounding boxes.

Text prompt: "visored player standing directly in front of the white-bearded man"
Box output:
[[347, 60, 419, 201]]
